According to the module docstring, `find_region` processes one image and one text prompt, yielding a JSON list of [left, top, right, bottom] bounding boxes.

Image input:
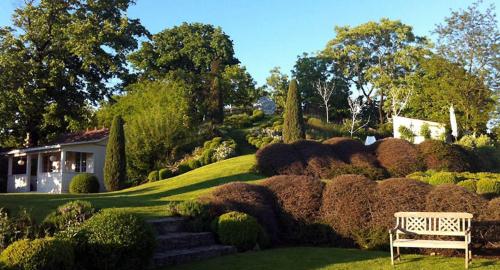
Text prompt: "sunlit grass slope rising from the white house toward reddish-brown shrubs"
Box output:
[[0, 155, 262, 221]]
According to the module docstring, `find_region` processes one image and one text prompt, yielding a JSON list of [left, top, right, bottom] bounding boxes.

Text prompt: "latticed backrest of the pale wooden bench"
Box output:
[[394, 212, 472, 236]]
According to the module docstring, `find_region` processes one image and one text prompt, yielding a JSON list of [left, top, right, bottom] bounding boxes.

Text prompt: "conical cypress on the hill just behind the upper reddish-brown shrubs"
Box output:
[[283, 79, 306, 143]]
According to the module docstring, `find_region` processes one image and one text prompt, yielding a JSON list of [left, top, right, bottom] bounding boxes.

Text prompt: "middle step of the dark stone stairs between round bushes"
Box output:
[[156, 232, 215, 251]]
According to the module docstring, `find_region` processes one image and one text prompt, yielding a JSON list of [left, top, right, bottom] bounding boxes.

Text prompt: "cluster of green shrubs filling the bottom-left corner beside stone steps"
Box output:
[[0, 201, 156, 270]]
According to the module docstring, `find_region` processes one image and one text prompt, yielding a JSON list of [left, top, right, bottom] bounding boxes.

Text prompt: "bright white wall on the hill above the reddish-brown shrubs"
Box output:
[[392, 116, 445, 143]]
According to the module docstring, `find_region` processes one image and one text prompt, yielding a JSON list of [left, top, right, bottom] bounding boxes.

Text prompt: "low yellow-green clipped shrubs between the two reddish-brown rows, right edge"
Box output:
[[407, 170, 500, 196]]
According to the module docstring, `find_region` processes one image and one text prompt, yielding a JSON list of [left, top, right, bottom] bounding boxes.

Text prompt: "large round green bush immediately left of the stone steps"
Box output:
[[78, 209, 156, 270]]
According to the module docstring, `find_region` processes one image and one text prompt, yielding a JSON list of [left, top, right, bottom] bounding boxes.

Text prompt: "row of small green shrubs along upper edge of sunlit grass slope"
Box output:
[[148, 137, 237, 182]]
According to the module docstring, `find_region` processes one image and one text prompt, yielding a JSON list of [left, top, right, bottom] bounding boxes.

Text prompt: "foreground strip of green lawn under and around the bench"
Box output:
[[167, 247, 500, 270]]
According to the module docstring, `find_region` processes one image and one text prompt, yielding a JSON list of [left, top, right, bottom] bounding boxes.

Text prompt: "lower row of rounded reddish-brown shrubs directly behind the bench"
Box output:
[[184, 175, 500, 250]]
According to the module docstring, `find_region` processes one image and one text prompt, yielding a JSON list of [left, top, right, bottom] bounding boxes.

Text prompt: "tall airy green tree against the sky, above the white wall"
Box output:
[[321, 18, 428, 123]]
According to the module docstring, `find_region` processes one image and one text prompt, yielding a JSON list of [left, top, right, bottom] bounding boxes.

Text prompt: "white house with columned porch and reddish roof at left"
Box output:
[[3, 128, 109, 193]]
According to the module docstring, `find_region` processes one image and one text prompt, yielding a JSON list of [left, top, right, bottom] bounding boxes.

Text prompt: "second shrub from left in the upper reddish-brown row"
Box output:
[[292, 140, 344, 178]]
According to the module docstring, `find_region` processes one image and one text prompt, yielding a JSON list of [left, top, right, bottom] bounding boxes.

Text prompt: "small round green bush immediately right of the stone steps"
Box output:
[[214, 211, 263, 251]]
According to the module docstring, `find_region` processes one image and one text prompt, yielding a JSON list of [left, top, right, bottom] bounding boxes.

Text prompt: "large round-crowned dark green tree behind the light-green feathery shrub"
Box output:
[[130, 23, 239, 123]]
